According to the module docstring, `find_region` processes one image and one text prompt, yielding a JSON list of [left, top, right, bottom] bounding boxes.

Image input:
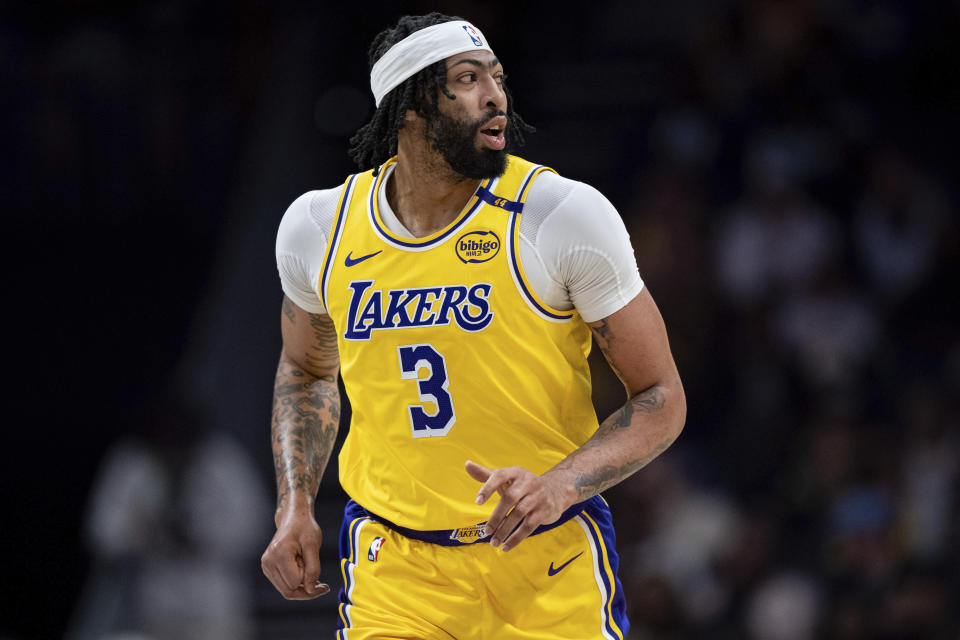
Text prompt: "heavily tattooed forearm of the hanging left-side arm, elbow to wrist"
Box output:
[[271, 354, 340, 513]]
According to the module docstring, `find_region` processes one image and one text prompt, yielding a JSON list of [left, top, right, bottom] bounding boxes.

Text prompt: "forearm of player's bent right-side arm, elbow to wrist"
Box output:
[[544, 379, 686, 504]]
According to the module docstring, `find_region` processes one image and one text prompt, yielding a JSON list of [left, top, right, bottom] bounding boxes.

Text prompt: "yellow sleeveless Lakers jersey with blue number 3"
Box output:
[[320, 156, 598, 530]]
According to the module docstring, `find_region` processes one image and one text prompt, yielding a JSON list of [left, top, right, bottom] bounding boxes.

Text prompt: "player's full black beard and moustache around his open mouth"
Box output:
[[427, 111, 509, 180]]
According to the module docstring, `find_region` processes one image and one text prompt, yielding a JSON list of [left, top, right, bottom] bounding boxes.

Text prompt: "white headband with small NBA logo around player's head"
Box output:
[[370, 20, 493, 107]]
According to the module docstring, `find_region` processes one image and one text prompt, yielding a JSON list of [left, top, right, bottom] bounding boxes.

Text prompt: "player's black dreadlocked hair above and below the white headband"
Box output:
[[349, 12, 536, 175]]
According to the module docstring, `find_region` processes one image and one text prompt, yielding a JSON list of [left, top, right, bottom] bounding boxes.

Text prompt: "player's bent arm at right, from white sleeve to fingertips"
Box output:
[[467, 289, 687, 551]]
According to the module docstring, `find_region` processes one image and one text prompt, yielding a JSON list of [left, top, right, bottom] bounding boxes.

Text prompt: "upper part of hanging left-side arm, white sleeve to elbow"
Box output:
[[280, 296, 340, 381]]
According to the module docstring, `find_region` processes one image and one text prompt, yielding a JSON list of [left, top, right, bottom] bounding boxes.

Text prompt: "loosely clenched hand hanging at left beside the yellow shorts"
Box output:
[[260, 512, 330, 600]]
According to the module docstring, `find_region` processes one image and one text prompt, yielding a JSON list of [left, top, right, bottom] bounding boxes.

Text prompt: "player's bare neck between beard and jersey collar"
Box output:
[[386, 145, 480, 238]]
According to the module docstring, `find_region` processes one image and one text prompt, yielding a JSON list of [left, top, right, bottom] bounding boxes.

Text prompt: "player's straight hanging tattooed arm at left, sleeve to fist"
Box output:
[[260, 296, 340, 600]]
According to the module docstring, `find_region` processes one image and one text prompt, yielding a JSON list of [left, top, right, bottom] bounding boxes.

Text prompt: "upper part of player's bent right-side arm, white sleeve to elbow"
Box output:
[[588, 287, 680, 397]]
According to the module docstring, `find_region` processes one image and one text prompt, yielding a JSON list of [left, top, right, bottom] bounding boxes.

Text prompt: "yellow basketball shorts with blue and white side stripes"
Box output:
[[337, 496, 629, 640]]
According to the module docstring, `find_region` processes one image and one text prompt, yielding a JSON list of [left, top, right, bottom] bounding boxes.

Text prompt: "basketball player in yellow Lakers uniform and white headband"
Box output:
[[262, 14, 686, 639]]
